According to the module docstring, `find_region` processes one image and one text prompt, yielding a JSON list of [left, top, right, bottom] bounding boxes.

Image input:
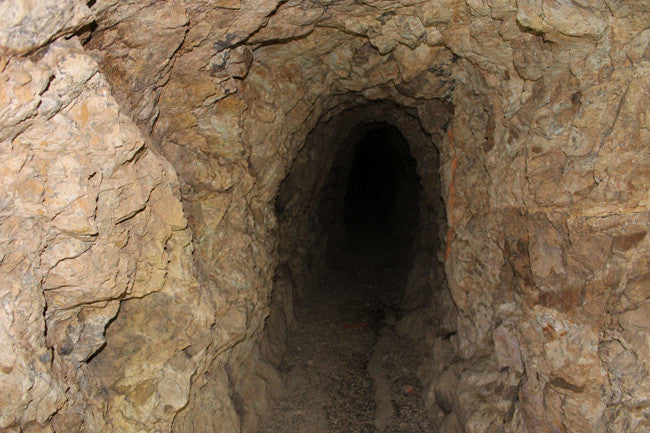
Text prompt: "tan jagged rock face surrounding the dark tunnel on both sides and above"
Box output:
[[0, 0, 650, 433]]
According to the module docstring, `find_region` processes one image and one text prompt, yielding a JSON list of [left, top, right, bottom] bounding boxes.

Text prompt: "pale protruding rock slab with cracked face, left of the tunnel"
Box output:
[[0, 38, 212, 431]]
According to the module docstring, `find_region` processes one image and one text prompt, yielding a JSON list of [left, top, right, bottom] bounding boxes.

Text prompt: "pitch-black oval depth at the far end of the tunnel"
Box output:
[[317, 123, 422, 320]]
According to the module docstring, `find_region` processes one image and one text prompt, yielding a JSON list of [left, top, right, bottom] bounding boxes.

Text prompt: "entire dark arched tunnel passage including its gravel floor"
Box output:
[[260, 113, 441, 433]]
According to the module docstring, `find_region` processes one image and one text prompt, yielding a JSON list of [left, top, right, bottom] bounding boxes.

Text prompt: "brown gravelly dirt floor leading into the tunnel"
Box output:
[[260, 232, 435, 433]]
